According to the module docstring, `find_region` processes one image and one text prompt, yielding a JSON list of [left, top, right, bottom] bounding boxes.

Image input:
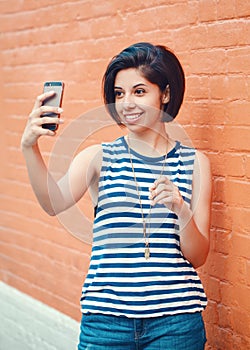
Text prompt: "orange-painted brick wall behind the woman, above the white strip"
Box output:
[[0, 0, 250, 350]]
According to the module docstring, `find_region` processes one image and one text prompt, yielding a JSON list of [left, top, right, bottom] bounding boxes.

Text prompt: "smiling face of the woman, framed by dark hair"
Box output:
[[114, 68, 168, 130]]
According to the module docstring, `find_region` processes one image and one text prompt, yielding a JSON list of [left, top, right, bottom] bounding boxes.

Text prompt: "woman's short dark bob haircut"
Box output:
[[103, 42, 185, 125]]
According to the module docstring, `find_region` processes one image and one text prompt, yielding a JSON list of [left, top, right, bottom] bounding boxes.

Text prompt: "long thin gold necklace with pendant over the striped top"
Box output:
[[127, 138, 168, 260]]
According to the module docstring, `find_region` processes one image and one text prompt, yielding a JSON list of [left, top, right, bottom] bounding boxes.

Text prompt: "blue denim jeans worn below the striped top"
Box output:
[[78, 312, 206, 350]]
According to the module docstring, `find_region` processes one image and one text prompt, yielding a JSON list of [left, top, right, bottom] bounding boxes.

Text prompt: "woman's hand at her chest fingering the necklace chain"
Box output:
[[149, 176, 184, 215]]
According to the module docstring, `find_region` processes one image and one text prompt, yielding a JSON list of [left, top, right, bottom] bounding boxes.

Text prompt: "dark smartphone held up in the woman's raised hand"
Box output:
[[41, 81, 64, 131]]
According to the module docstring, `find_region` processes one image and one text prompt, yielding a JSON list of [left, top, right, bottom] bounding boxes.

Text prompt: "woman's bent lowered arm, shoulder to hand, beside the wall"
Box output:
[[151, 151, 212, 268]]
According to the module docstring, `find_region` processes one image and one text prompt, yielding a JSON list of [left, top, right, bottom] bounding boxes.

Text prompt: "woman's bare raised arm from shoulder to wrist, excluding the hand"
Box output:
[[23, 145, 101, 216]]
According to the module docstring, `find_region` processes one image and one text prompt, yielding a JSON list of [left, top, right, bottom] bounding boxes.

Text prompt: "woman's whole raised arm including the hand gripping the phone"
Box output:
[[21, 93, 101, 215]]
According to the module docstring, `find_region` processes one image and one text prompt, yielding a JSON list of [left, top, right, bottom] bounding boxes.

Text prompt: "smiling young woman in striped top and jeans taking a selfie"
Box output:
[[21, 43, 211, 350]]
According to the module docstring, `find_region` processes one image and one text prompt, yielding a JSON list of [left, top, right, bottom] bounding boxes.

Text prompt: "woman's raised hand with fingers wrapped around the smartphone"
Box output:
[[21, 91, 63, 149]]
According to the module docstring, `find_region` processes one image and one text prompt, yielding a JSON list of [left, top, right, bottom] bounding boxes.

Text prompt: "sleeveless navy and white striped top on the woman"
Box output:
[[81, 137, 207, 318]]
